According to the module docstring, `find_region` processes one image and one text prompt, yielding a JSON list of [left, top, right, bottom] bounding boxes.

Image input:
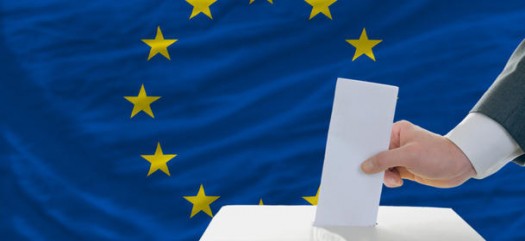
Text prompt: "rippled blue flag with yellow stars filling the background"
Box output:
[[0, 0, 525, 240]]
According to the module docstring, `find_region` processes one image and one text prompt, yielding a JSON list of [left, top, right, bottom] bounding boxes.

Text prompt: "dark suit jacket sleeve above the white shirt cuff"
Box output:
[[471, 40, 525, 165]]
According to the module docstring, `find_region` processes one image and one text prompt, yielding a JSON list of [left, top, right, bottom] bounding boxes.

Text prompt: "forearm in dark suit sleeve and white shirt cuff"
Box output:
[[447, 41, 525, 178]]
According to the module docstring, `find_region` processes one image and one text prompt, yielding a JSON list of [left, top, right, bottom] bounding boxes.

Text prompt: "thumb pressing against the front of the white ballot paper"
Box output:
[[361, 146, 410, 174]]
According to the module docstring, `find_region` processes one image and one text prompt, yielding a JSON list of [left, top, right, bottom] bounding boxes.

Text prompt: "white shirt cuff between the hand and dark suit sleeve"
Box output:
[[445, 113, 523, 179]]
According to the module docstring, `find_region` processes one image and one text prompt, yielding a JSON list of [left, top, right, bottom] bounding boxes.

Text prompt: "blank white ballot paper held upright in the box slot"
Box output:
[[314, 78, 398, 227]]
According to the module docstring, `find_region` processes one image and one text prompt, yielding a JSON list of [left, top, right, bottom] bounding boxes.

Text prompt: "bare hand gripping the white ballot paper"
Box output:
[[361, 121, 476, 188]]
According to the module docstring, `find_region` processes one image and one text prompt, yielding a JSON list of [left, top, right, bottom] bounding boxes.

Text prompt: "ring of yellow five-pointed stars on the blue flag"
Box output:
[[124, 0, 382, 218]]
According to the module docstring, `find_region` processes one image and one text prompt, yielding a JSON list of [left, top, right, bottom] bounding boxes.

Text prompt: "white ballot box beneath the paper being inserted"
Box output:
[[201, 205, 484, 241]]
